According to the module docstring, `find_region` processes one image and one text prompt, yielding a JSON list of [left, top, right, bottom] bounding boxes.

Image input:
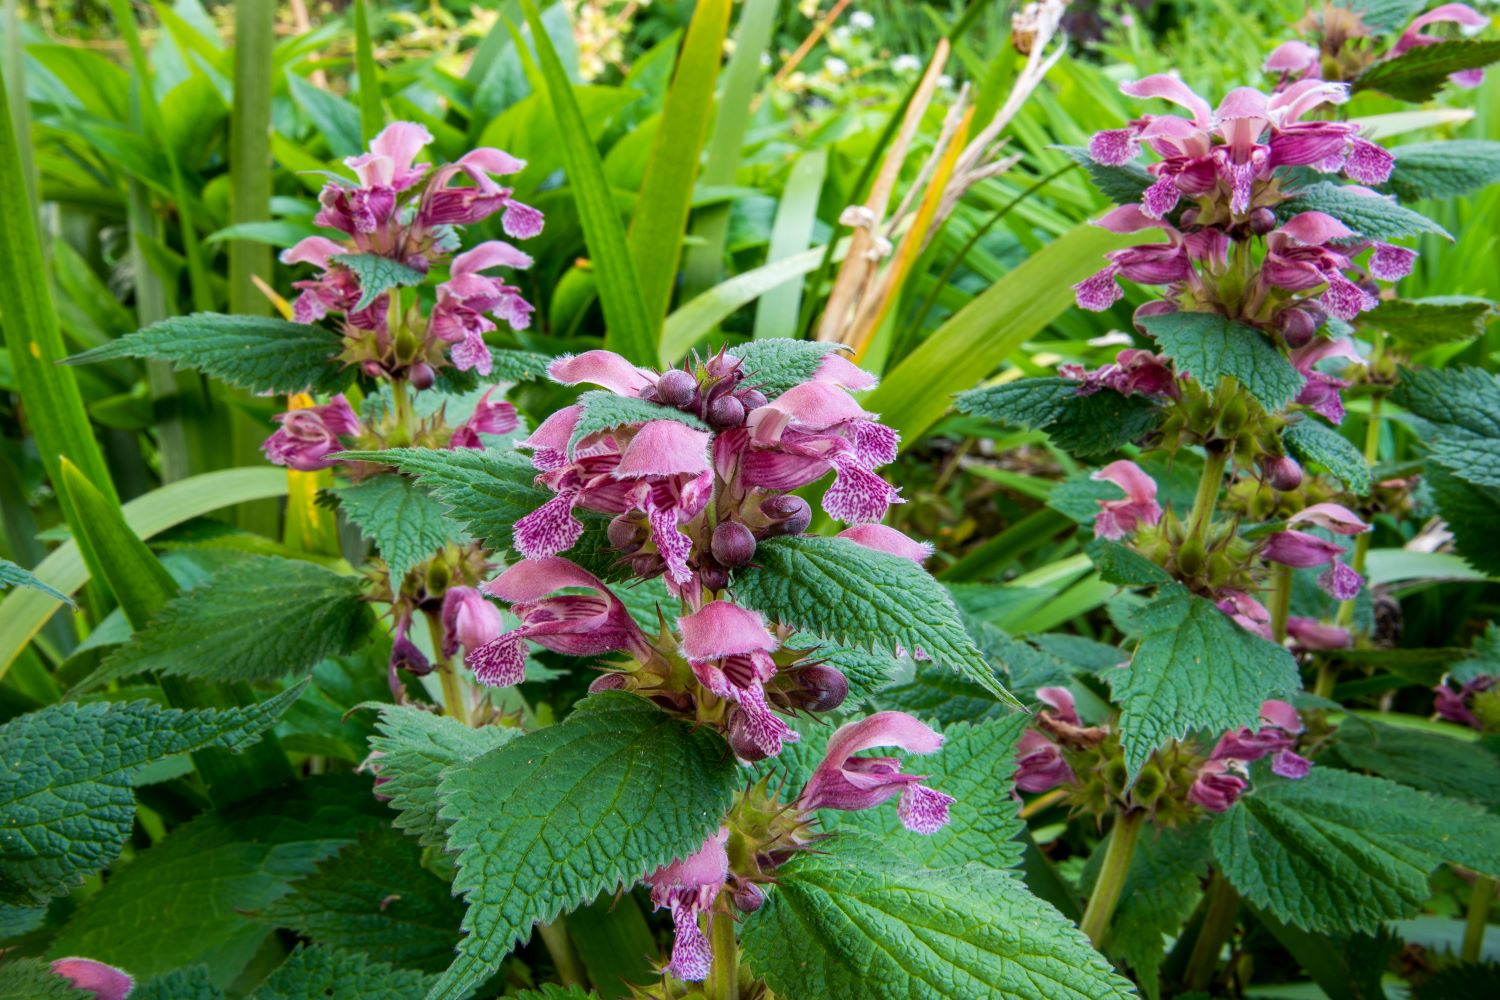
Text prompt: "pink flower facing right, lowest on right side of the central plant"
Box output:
[[797, 712, 954, 834]]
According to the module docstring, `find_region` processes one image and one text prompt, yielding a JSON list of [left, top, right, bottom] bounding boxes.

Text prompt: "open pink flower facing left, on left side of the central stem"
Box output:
[[465, 558, 651, 687]]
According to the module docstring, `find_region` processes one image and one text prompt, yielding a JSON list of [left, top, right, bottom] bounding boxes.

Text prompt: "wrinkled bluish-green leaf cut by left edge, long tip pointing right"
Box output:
[[0, 685, 302, 906]]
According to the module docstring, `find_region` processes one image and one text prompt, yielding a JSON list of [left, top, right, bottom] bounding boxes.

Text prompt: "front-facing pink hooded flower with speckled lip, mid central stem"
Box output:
[[677, 601, 798, 757]]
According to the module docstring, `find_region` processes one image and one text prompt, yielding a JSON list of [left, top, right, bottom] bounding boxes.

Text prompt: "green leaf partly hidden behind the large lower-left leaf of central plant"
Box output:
[[371, 705, 521, 847]]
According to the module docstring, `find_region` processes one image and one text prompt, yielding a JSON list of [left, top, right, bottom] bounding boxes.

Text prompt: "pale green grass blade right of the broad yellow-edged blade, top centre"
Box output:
[[683, 0, 780, 301]]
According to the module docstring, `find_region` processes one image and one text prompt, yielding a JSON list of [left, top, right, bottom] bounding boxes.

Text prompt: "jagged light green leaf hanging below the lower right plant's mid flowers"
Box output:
[[1107, 586, 1299, 775]]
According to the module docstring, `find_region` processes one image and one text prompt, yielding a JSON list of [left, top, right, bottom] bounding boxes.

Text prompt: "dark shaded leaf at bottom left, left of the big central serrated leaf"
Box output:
[[255, 827, 464, 973]]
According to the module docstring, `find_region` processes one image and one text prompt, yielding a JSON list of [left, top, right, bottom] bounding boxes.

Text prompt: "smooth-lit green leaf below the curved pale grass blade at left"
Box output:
[[78, 556, 375, 690]]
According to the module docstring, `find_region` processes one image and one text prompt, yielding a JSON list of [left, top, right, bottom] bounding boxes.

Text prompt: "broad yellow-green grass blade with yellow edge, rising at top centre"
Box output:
[[626, 0, 732, 335]]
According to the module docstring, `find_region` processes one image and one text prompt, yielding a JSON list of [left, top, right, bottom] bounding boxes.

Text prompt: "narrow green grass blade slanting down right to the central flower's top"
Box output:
[[521, 0, 657, 364]]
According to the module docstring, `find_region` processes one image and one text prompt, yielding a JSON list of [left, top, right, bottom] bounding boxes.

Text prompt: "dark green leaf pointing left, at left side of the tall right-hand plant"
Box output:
[[954, 378, 1163, 457]]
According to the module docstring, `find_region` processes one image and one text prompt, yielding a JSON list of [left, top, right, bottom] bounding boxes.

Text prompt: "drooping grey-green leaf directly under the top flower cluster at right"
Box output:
[[1142, 312, 1304, 412]]
